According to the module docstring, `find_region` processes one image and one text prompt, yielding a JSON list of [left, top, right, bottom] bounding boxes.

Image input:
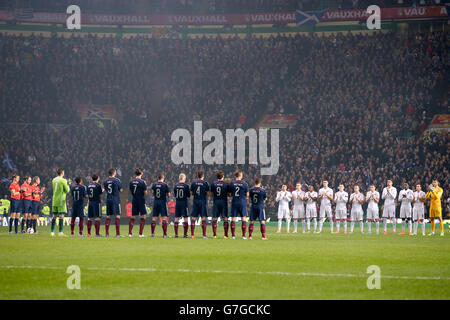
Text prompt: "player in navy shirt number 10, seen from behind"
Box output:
[[173, 173, 191, 238]]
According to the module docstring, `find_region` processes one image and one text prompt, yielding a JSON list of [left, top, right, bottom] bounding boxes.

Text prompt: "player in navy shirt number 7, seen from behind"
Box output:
[[128, 168, 148, 238]]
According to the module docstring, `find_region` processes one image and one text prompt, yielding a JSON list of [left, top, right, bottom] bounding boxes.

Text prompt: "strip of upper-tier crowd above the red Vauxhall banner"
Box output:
[[1, 0, 443, 14]]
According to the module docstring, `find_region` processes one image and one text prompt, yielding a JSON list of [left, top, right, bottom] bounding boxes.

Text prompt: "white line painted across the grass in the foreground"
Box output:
[[0, 266, 450, 280]]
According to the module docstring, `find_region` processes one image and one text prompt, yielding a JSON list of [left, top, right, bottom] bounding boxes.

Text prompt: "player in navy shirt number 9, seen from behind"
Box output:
[[211, 171, 230, 239]]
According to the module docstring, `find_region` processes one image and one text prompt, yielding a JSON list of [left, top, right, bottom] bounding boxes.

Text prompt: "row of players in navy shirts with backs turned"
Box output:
[[70, 168, 267, 240]]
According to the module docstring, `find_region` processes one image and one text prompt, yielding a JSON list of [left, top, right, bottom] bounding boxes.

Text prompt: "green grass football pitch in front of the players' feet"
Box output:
[[0, 224, 450, 300]]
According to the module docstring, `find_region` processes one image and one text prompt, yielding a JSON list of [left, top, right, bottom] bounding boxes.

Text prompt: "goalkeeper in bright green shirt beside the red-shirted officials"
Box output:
[[50, 168, 70, 237]]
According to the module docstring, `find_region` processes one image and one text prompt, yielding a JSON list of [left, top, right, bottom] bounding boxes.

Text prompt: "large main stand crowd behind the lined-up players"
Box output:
[[0, 28, 450, 216]]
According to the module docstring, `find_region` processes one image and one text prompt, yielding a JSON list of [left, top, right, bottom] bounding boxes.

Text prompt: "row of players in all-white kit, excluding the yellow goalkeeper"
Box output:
[[276, 180, 426, 235]]
